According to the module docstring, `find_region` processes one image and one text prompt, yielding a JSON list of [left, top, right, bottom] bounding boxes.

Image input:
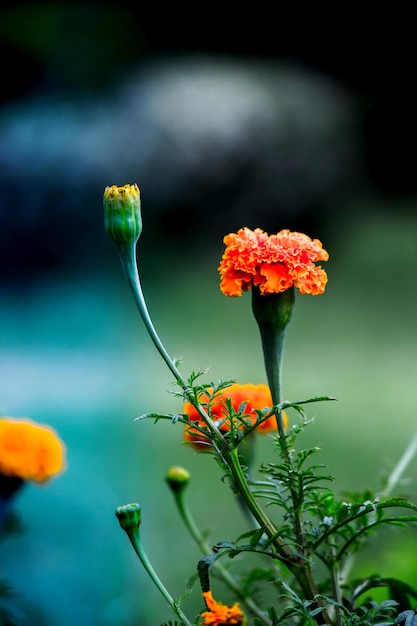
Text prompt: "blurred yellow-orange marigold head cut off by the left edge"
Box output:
[[0, 417, 65, 483]]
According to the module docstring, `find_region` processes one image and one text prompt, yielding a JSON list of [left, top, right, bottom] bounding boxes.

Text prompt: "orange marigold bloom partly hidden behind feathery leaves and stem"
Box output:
[[183, 383, 287, 448]]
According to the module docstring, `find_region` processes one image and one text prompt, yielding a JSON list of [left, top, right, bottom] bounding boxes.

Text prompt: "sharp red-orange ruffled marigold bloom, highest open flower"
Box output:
[[219, 228, 329, 296]]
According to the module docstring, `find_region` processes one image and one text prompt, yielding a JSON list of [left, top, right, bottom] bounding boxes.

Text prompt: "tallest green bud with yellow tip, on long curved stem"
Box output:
[[103, 184, 142, 245]]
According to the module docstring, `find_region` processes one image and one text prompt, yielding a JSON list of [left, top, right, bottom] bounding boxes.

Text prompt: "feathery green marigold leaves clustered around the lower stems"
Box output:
[[138, 372, 417, 626]]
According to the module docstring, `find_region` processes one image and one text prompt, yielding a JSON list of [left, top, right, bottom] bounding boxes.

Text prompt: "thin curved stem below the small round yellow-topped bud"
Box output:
[[174, 491, 272, 626]]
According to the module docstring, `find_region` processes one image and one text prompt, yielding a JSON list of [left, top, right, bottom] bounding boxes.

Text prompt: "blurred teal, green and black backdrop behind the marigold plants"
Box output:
[[0, 2, 417, 626]]
